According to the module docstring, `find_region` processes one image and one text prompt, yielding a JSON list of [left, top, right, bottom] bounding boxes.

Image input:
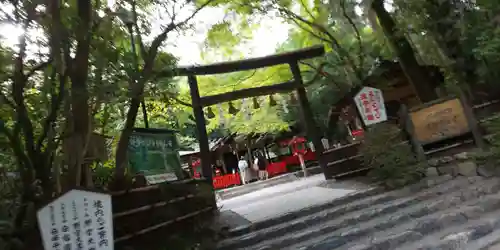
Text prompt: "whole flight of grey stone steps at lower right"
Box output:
[[217, 175, 500, 250]]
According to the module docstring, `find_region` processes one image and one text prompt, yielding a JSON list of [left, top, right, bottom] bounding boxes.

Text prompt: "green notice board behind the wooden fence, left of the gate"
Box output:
[[128, 128, 182, 184]]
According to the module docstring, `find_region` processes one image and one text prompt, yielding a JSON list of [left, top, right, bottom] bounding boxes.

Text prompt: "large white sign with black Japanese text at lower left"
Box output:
[[37, 190, 114, 250]]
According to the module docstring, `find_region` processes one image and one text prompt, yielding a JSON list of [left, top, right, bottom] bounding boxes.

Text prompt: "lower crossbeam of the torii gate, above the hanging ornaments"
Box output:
[[201, 81, 301, 107]]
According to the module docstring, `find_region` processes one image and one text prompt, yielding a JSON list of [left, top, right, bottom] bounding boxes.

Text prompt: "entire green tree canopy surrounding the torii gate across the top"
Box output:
[[0, 0, 500, 248]]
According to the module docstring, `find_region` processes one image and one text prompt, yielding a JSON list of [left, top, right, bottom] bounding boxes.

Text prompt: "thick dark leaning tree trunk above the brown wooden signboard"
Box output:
[[371, 0, 437, 102]]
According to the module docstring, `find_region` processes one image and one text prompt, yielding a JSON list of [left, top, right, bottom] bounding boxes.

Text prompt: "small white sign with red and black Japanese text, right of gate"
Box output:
[[354, 87, 387, 126]]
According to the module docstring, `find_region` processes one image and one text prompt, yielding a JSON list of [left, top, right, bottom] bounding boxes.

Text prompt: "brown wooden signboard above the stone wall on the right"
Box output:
[[410, 98, 471, 144]]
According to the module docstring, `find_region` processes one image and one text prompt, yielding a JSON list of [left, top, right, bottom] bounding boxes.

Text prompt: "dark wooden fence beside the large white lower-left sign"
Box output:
[[112, 180, 216, 249]]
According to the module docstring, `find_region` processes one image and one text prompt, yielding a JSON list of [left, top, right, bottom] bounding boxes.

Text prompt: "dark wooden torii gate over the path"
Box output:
[[176, 46, 326, 181]]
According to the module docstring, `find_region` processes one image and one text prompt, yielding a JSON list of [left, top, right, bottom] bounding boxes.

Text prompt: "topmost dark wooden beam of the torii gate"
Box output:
[[175, 45, 325, 76]]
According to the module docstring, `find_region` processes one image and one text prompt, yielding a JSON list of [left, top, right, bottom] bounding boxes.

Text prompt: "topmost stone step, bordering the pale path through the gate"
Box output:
[[218, 176, 456, 250]]
